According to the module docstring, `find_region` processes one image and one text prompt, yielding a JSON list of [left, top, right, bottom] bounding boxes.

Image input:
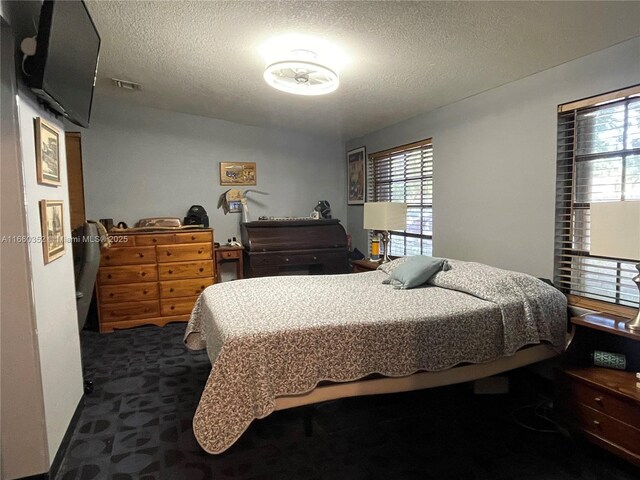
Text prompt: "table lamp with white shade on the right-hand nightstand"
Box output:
[[589, 201, 640, 333]]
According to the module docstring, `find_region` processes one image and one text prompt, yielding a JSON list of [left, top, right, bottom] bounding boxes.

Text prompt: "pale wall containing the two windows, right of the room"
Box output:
[[346, 38, 640, 278]]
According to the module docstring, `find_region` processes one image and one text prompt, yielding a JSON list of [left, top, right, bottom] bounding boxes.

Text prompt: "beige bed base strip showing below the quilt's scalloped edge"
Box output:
[[275, 344, 558, 410]]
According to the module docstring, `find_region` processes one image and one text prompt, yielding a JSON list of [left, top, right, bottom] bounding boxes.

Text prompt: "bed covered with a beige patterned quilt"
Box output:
[[185, 260, 567, 453]]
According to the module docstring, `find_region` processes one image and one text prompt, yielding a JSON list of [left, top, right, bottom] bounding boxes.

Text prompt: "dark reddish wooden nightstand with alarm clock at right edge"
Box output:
[[556, 314, 640, 466]]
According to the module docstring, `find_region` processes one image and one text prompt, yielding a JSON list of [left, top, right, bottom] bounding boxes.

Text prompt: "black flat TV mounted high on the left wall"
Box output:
[[25, 0, 100, 127]]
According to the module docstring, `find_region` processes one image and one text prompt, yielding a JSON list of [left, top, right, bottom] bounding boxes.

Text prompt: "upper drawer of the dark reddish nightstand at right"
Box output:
[[565, 376, 640, 429]]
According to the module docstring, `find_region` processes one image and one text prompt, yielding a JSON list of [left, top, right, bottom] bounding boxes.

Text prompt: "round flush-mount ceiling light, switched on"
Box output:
[[264, 49, 340, 95]]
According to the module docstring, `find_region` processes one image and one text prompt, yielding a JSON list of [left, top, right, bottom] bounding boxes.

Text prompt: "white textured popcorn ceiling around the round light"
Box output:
[[87, 0, 640, 139]]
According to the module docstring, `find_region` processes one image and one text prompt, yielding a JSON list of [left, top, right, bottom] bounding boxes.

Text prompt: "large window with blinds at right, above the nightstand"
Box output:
[[554, 86, 640, 313]]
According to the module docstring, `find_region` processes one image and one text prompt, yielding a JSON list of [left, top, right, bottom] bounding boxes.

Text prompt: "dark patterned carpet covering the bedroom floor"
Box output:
[[56, 324, 639, 480]]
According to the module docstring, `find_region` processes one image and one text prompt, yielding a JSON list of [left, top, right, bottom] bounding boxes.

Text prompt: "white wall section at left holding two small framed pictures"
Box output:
[[18, 93, 83, 462]]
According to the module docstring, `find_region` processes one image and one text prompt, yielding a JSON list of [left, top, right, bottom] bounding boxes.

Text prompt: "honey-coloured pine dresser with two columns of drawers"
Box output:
[[96, 230, 216, 332]]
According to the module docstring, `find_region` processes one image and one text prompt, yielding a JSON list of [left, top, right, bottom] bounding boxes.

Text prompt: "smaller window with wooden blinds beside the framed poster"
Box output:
[[367, 139, 433, 256]]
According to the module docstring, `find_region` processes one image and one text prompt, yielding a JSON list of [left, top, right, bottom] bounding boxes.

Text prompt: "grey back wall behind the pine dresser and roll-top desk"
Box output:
[[82, 93, 346, 243]]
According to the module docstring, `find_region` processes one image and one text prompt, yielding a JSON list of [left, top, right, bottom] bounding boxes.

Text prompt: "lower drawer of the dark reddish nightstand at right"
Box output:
[[572, 403, 640, 455]]
